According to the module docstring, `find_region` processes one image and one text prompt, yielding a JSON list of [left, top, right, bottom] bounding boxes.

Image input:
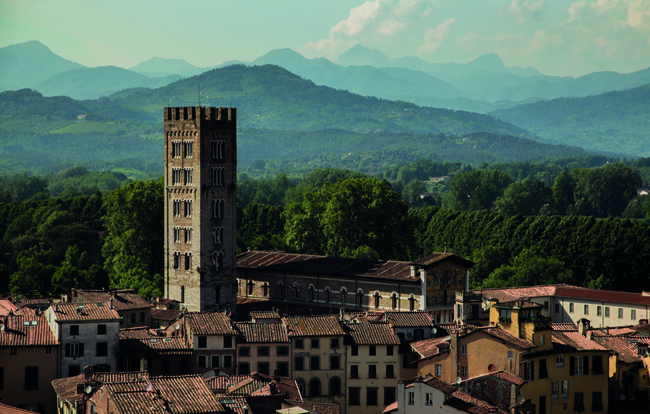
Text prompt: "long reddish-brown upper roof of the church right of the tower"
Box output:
[[237, 252, 420, 283]]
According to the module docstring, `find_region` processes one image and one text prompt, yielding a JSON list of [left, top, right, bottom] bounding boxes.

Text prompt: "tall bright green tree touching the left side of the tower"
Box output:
[[102, 179, 164, 295]]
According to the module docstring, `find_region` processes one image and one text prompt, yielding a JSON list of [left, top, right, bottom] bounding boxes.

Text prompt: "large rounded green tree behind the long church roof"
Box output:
[[284, 178, 413, 260]]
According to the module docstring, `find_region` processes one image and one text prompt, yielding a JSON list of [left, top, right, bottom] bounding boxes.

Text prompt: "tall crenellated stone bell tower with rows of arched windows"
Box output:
[[164, 107, 237, 311]]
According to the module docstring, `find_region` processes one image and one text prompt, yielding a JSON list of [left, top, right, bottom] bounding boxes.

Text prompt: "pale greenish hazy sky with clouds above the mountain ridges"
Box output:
[[0, 0, 650, 76]]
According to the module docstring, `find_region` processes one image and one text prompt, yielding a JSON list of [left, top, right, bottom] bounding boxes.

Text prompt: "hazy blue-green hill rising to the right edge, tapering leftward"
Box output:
[[490, 84, 650, 157]]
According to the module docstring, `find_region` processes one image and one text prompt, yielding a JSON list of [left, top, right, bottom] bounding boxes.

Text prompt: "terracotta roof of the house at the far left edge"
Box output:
[[0, 311, 58, 347]]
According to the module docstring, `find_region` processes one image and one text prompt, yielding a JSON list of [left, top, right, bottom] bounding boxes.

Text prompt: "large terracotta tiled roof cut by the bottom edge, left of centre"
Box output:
[[104, 375, 224, 414]]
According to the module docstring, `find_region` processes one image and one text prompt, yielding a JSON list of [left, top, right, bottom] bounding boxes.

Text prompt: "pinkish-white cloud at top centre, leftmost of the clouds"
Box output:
[[299, 0, 432, 60]]
